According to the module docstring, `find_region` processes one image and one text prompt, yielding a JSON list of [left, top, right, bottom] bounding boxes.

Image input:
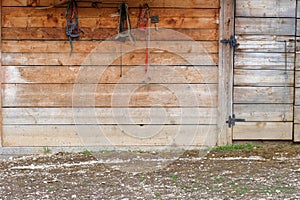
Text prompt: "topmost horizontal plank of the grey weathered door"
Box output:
[[236, 0, 296, 17]]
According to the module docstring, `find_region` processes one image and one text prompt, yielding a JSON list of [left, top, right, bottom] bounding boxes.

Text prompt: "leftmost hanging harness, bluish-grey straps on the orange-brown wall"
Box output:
[[66, 0, 82, 53]]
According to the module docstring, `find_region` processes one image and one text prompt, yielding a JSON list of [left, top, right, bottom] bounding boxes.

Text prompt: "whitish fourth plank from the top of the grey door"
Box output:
[[234, 53, 295, 70]]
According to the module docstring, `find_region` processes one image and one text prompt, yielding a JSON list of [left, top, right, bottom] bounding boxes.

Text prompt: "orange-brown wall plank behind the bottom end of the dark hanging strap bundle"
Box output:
[[2, 27, 218, 41]]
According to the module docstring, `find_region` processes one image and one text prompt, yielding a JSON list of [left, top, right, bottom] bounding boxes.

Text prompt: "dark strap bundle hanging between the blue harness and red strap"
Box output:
[[116, 3, 135, 44]]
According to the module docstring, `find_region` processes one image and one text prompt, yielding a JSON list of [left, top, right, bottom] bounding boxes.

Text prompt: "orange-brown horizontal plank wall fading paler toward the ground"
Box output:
[[2, 0, 219, 146]]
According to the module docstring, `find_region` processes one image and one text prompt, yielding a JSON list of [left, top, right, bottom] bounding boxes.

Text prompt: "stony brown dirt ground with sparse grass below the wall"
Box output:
[[0, 144, 300, 200]]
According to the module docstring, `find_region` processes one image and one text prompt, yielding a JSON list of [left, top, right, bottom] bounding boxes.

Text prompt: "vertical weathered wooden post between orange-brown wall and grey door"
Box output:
[[218, 0, 234, 146]]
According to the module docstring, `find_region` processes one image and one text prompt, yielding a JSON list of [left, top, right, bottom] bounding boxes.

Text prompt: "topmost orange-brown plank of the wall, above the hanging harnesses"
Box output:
[[2, 0, 219, 8]]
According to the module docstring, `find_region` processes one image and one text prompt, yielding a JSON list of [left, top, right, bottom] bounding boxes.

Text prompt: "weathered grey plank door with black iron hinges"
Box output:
[[233, 0, 300, 140]]
